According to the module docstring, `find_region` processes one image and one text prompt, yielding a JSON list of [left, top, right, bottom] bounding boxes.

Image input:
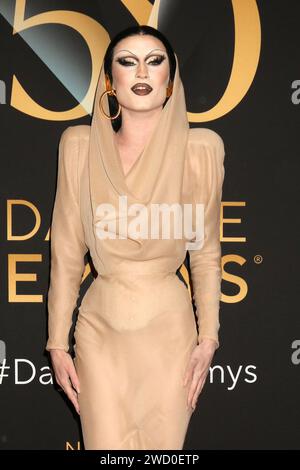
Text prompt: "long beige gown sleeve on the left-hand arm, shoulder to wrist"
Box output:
[[46, 126, 88, 351]]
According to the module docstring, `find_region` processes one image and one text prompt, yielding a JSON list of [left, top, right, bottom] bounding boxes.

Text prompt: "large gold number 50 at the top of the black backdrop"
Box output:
[[11, 0, 261, 122]]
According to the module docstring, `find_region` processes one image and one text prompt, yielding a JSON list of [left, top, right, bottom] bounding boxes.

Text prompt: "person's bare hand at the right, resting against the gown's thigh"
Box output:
[[183, 338, 217, 411]]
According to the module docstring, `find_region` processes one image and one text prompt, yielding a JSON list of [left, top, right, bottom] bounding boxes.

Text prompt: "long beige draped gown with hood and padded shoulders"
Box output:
[[46, 53, 225, 450]]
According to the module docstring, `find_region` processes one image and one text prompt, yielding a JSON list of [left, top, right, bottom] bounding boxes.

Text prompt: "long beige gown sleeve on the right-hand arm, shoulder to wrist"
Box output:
[[189, 128, 225, 348]]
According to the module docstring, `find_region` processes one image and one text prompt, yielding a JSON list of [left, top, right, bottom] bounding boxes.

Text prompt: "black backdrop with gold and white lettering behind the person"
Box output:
[[0, 0, 300, 450]]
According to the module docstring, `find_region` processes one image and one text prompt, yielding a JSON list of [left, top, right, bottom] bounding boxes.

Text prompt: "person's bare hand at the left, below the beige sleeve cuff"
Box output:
[[50, 349, 80, 414]]
